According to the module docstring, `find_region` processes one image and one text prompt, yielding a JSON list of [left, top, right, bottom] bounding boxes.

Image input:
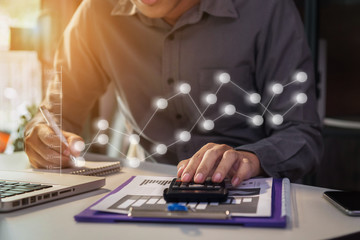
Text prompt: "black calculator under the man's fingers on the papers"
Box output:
[[163, 178, 228, 202]]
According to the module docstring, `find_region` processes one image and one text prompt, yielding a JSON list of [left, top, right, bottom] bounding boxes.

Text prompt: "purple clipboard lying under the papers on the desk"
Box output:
[[74, 176, 286, 228]]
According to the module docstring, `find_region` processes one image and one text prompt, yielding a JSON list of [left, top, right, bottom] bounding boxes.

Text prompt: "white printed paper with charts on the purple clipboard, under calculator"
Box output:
[[91, 176, 273, 217]]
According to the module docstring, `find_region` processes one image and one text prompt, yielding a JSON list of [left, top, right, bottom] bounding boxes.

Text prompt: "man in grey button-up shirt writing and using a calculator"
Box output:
[[26, 0, 322, 186]]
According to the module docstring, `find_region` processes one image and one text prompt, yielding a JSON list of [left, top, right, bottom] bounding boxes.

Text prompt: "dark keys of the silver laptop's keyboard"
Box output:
[[0, 181, 52, 198]]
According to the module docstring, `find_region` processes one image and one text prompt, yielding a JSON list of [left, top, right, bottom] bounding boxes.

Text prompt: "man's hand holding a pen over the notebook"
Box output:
[[25, 124, 83, 169]]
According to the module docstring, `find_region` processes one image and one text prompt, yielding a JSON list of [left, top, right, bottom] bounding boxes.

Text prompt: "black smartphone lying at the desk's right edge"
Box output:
[[324, 191, 360, 216]]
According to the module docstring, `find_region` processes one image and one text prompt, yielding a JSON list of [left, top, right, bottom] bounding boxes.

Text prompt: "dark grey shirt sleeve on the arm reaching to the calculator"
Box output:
[[236, 0, 323, 181]]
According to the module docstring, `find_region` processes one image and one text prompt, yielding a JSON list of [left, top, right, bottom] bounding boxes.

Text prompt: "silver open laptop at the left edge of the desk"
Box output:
[[0, 171, 105, 212]]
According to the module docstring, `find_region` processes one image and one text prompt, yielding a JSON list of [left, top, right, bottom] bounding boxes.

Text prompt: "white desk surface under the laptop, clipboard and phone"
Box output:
[[0, 153, 360, 240]]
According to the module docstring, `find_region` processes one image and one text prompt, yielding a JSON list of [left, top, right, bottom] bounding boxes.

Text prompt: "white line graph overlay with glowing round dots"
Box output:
[[76, 71, 308, 166]]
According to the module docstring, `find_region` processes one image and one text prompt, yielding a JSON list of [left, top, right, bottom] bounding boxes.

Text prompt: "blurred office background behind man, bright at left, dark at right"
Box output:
[[0, 0, 360, 190]]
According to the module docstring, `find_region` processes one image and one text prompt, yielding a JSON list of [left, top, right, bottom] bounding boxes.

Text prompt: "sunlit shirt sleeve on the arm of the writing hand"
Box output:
[[26, 1, 109, 135]]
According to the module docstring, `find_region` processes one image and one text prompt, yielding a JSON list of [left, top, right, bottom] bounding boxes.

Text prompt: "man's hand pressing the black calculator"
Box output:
[[177, 143, 263, 186]]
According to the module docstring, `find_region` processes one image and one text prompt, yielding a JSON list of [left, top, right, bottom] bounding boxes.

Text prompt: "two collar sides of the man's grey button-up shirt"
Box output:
[[111, 0, 238, 18]]
